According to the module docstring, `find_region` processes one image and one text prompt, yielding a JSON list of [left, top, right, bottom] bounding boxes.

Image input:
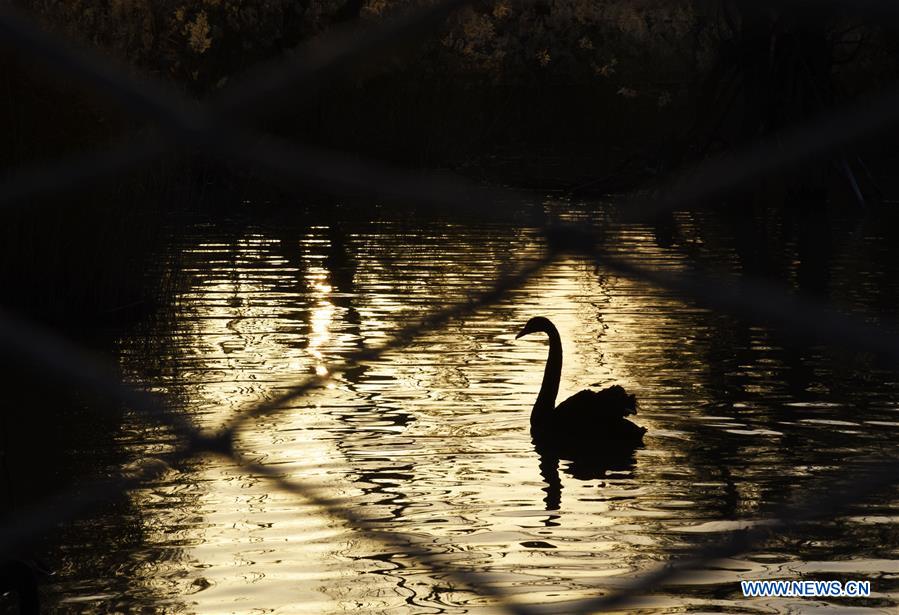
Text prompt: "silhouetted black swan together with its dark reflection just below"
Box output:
[[515, 316, 646, 510]]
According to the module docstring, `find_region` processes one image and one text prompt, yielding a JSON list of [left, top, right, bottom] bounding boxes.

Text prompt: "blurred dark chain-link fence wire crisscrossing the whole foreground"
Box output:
[[0, 1, 899, 613]]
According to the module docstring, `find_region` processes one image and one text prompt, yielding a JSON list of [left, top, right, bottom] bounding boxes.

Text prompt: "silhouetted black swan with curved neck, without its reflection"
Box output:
[[516, 316, 646, 452]]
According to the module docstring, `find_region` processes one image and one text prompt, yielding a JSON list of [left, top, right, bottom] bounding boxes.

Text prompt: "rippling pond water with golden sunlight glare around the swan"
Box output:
[[5, 201, 899, 614]]
